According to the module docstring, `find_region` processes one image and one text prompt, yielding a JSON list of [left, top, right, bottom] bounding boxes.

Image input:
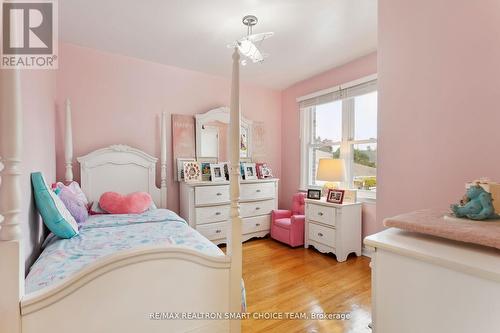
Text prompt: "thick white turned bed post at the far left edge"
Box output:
[[0, 69, 24, 333]]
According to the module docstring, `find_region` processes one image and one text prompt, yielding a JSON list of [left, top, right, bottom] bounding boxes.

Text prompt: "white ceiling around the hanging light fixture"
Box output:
[[59, 0, 377, 89]]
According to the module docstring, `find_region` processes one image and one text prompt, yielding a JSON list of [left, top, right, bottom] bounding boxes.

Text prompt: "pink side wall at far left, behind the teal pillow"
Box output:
[[21, 70, 56, 267]]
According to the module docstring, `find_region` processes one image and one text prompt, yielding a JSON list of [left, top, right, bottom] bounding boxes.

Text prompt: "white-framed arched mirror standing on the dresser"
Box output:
[[195, 107, 252, 161]]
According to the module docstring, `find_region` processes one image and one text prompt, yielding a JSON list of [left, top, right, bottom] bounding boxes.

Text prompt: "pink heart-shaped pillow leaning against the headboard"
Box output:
[[99, 192, 153, 214]]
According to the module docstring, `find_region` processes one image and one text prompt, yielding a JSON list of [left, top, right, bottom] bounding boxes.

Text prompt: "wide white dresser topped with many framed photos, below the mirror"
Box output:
[[180, 178, 278, 244]]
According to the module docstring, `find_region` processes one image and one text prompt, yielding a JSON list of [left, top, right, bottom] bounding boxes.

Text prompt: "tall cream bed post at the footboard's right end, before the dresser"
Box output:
[[227, 48, 242, 333]]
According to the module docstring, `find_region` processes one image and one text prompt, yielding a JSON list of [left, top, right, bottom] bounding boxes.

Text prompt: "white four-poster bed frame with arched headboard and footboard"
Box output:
[[0, 49, 242, 333]]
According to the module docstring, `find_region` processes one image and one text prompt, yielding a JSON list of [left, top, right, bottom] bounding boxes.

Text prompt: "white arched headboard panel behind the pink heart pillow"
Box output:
[[77, 145, 167, 208]]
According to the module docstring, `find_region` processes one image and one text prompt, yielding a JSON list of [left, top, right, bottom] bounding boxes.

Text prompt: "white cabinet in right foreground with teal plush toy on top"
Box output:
[[364, 228, 500, 333]]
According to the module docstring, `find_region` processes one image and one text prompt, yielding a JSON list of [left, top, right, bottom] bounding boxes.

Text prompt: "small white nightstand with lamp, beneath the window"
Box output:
[[304, 199, 361, 262]]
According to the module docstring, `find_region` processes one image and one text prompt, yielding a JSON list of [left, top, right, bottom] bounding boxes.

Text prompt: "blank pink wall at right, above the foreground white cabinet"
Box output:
[[377, 0, 500, 224]]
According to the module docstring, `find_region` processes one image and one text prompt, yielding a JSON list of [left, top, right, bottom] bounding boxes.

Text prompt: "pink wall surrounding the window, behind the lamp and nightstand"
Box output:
[[281, 53, 377, 236]]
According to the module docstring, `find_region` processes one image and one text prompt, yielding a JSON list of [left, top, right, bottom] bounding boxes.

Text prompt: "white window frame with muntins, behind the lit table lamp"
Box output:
[[297, 74, 378, 201]]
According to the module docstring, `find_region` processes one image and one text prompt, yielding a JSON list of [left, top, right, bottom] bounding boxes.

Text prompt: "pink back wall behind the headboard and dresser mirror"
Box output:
[[56, 43, 281, 211]]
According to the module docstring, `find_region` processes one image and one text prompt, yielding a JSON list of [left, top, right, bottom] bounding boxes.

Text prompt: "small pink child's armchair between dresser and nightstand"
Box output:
[[271, 193, 306, 247]]
